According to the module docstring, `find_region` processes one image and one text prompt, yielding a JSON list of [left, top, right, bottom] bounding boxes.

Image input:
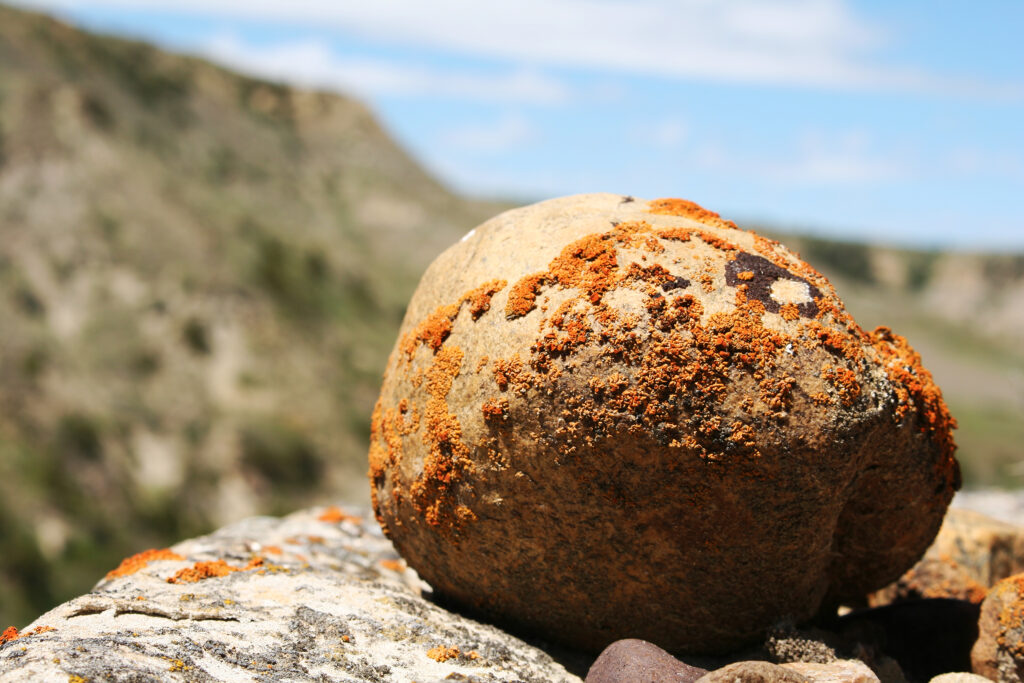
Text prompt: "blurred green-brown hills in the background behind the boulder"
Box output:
[[0, 6, 1024, 627]]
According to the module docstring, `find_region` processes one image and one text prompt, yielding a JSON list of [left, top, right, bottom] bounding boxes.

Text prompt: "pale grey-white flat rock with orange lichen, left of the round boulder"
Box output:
[[0, 509, 580, 683]]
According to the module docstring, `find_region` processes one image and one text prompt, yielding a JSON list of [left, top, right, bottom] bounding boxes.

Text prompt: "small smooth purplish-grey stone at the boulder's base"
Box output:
[[586, 638, 708, 683]]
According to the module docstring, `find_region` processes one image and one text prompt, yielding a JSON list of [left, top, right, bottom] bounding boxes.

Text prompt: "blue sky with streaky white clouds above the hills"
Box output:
[[9, 0, 1024, 251]]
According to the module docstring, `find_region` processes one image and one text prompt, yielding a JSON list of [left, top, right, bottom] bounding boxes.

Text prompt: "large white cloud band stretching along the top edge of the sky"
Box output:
[[12, 0, 1024, 97]]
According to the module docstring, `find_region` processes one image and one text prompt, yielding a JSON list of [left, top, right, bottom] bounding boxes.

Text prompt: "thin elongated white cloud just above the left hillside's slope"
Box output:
[[199, 36, 569, 104]]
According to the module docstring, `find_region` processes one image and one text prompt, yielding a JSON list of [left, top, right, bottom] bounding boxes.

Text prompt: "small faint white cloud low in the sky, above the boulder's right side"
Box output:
[[695, 131, 916, 186]]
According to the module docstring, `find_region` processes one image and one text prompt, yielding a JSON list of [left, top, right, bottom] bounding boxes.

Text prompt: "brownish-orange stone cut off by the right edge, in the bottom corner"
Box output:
[[971, 573, 1024, 683]]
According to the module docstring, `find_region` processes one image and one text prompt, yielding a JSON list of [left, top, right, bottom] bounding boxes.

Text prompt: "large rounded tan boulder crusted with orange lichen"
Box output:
[[370, 195, 958, 652]]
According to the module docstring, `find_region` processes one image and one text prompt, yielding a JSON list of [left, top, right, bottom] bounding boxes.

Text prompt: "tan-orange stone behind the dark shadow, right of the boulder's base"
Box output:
[[867, 507, 1024, 606]]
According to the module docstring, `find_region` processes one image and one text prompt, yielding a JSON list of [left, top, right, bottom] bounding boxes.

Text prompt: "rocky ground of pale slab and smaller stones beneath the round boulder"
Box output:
[[0, 492, 1024, 683]]
